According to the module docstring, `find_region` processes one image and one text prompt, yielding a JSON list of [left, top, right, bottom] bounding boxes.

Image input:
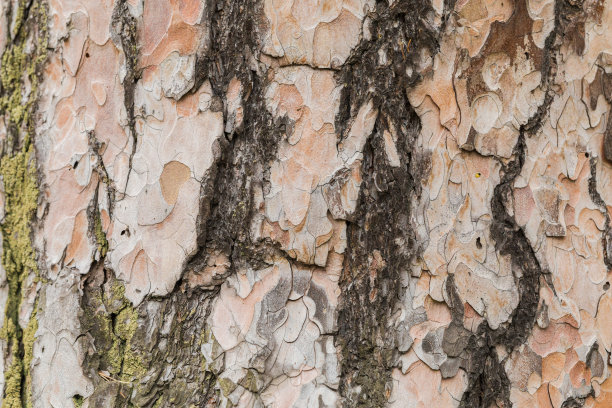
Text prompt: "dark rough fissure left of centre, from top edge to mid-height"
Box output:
[[191, 0, 282, 270]]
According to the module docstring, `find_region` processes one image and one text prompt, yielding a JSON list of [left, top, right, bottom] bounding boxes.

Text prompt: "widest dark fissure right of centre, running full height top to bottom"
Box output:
[[336, 1, 454, 407]]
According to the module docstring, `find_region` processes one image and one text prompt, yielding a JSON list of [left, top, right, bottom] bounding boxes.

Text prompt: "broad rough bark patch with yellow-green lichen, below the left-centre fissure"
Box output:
[[80, 263, 222, 407]]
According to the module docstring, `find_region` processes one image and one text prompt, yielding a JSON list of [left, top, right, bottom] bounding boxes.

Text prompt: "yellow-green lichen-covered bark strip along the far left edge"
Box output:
[[0, 0, 47, 408]]
